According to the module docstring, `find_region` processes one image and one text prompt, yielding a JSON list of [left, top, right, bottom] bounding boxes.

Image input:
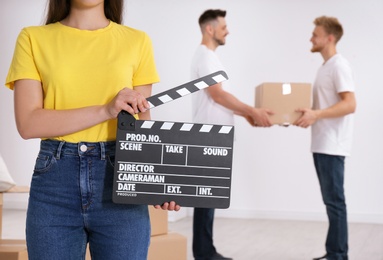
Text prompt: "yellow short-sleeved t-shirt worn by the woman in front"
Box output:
[[6, 22, 159, 143]]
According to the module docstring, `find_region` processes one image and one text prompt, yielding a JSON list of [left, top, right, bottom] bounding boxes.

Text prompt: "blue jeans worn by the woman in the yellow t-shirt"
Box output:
[[26, 140, 150, 260]]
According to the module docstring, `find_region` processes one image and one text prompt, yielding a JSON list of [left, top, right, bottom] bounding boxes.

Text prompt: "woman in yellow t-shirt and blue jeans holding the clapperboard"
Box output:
[[6, 0, 180, 260]]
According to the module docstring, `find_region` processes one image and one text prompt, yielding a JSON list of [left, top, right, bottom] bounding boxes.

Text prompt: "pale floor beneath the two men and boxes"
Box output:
[[3, 209, 383, 260]]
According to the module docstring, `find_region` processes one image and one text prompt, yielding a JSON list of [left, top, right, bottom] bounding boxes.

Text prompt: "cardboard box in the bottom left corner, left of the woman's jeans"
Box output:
[[0, 239, 28, 260]]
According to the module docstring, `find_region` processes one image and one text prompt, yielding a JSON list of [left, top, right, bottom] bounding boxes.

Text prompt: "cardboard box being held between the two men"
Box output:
[[255, 83, 312, 125]]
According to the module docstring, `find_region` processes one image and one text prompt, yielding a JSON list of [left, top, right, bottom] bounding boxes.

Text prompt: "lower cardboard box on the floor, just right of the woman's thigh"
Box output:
[[148, 232, 187, 260]]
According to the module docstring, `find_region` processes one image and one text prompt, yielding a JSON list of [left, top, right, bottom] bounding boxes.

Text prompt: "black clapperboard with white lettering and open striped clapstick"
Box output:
[[113, 71, 234, 208]]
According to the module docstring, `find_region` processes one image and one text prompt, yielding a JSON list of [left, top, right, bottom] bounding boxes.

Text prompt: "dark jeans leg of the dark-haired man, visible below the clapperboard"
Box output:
[[193, 208, 217, 259]]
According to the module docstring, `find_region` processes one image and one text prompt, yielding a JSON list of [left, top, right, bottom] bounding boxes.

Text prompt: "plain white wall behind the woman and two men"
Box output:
[[0, 0, 383, 223]]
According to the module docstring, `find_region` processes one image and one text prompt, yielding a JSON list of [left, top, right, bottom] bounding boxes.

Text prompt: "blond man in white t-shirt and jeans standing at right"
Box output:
[[295, 16, 356, 260]]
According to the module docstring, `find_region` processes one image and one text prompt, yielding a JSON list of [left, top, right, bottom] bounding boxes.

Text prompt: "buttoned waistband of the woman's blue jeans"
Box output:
[[40, 139, 116, 160]]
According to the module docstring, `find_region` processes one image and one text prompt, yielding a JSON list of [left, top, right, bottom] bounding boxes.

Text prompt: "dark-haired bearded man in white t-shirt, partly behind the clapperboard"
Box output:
[[191, 10, 272, 260]]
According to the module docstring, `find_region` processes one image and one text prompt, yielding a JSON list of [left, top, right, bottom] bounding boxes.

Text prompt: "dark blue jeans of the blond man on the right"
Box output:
[[313, 153, 348, 260]]
